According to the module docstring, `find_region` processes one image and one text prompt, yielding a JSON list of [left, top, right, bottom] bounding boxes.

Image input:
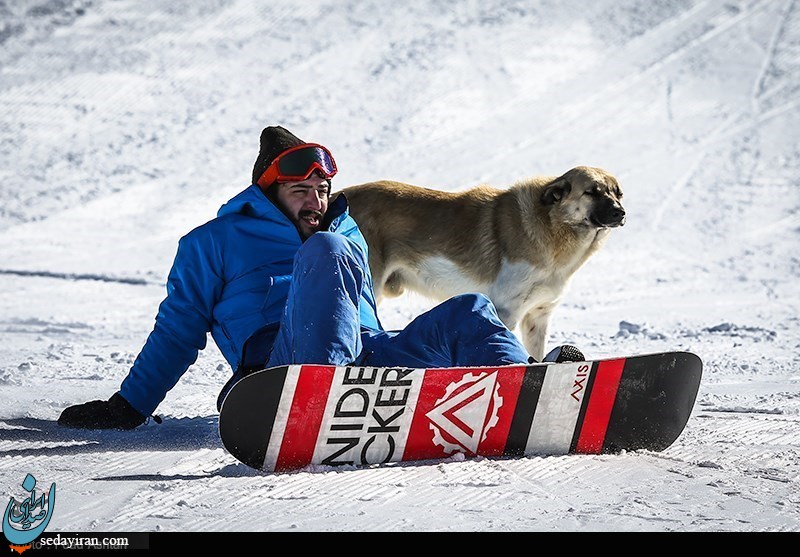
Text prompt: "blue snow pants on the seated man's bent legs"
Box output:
[[267, 232, 529, 368]]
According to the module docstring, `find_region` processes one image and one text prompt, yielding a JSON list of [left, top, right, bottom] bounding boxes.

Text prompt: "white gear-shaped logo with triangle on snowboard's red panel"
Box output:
[[425, 371, 503, 454]]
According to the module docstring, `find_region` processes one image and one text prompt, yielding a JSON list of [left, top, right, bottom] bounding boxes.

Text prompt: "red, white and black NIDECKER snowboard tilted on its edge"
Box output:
[[219, 352, 703, 472]]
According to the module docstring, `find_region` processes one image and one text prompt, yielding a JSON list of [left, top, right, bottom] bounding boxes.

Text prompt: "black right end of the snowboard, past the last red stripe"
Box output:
[[602, 352, 703, 453]]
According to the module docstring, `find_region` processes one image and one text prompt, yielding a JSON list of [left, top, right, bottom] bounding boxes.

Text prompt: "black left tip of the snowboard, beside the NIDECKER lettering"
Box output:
[[219, 366, 288, 469]]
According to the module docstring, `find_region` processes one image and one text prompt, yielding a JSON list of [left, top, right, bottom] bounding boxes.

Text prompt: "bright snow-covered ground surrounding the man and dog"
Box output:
[[0, 0, 800, 532]]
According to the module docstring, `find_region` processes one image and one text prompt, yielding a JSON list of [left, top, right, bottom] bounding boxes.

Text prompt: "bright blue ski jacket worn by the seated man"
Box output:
[[120, 184, 383, 416]]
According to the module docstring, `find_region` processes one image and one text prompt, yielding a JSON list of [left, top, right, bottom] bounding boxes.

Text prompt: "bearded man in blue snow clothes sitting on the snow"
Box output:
[[58, 126, 580, 429]]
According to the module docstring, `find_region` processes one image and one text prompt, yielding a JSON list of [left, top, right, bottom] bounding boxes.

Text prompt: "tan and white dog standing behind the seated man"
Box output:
[[341, 166, 625, 361]]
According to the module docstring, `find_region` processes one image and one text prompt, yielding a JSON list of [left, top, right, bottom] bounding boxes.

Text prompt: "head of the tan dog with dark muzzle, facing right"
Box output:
[[541, 166, 625, 228]]
